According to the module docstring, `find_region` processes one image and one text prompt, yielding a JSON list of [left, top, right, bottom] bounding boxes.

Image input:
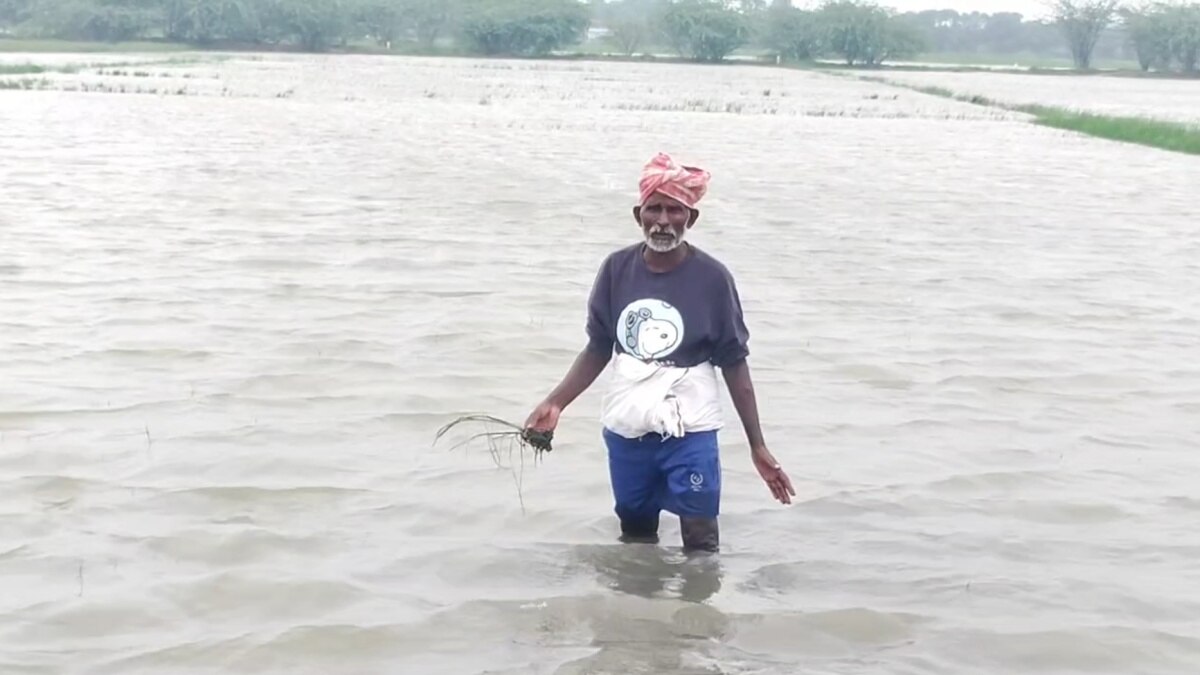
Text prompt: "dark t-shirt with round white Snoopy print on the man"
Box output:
[[587, 243, 750, 368]]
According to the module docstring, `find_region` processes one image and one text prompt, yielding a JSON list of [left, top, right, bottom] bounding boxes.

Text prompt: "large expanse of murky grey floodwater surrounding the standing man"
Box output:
[[0, 55, 1200, 675]]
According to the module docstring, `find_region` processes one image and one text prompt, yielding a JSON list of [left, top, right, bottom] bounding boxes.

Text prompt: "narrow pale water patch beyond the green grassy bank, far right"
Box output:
[[864, 71, 1200, 125]]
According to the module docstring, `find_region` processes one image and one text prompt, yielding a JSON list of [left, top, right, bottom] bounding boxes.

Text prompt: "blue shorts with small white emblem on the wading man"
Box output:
[[604, 429, 721, 522]]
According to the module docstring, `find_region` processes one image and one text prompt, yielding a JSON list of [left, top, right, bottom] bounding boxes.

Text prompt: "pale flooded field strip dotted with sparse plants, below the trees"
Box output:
[[0, 53, 1012, 123]]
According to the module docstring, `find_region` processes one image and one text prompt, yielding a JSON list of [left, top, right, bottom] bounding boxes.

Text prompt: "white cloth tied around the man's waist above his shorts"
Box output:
[[600, 353, 724, 438]]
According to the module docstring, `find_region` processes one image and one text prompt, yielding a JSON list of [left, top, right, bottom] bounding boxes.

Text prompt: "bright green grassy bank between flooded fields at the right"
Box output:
[[863, 77, 1200, 155]]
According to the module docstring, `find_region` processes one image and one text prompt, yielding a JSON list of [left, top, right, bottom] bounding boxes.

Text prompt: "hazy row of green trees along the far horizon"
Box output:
[[0, 0, 1200, 73]]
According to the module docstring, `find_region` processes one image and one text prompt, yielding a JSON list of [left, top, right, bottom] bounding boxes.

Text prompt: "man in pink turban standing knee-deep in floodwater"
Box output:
[[526, 154, 796, 552]]
